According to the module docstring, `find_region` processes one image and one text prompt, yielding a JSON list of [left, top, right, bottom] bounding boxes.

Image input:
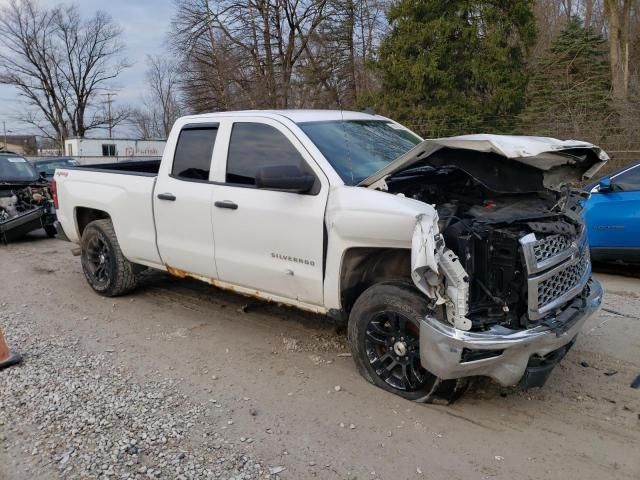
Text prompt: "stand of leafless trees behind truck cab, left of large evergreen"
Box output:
[[171, 0, 389, 111]]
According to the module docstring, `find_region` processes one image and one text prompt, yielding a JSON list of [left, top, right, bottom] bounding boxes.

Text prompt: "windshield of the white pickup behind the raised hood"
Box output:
[[299, 120, 421, 185]]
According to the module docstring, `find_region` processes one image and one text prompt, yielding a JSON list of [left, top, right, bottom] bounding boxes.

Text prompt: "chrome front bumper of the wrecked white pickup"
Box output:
[[420, 279, 603, 386]]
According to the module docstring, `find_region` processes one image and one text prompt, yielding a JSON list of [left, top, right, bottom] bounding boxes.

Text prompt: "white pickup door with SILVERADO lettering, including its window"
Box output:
[[213, 118, 329, 305]]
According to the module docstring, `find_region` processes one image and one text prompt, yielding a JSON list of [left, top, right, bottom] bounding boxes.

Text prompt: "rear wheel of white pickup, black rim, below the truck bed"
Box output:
[[81, 219, 137, 297]]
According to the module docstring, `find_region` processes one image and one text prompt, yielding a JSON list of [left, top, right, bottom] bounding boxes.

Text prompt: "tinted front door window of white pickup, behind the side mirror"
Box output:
[[226, 122, 310, 185]]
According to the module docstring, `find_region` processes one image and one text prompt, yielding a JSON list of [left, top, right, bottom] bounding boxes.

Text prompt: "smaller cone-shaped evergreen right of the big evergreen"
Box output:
[[522, 17, 614, 141]]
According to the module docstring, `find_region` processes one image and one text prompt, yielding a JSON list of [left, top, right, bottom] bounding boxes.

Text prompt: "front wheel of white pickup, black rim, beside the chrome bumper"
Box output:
[[349, 282, 467, 403]]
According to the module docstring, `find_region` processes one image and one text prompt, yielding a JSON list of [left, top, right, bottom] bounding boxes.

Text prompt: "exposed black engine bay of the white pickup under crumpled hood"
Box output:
[[387, 159, 584, 331]]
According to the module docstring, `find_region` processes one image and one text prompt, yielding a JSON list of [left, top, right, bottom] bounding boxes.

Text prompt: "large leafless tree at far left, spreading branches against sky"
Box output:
[[0, 0, 128, 146]]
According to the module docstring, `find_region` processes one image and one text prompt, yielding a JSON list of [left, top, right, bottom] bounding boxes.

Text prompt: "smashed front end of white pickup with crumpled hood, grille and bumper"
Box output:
[[384, 136, 606, 387]]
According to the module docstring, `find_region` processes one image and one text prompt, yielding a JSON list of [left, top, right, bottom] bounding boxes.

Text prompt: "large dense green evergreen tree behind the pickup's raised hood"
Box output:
[[369, 0, 535, 136]]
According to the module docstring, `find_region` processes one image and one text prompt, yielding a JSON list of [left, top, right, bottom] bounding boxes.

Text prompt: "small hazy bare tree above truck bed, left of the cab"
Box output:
[[131, 56, 182, 138]]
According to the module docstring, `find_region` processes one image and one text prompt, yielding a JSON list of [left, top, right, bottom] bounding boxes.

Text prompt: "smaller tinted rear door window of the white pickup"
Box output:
[[171, 126, 218, 180]]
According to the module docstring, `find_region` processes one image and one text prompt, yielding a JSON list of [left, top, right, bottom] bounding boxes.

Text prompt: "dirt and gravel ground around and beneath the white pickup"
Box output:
[[0, 234, 640, 480]]
